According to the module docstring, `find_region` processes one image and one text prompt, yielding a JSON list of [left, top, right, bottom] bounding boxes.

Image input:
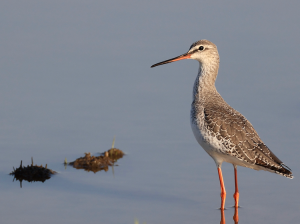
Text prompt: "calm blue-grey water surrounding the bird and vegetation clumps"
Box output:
[[0, 0, 300, 224]]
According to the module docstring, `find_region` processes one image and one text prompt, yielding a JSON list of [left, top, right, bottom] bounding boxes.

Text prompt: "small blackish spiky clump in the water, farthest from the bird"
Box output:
[[10, 157, 56, 187]]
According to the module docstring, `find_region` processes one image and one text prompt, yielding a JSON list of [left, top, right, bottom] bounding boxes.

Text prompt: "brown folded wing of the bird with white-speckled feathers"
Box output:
[[204, 106, 291, 178]]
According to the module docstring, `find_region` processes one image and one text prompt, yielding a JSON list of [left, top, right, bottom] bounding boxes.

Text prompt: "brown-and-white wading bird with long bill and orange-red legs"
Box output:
[[151, 40, 293, 209]]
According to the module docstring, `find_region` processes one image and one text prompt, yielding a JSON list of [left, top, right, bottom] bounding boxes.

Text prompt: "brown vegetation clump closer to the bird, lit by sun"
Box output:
[[69, 148, 124, 173]]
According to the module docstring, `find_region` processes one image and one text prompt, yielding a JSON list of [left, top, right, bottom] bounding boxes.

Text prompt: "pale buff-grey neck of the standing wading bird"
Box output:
[[193, 63, 219, 101]]
